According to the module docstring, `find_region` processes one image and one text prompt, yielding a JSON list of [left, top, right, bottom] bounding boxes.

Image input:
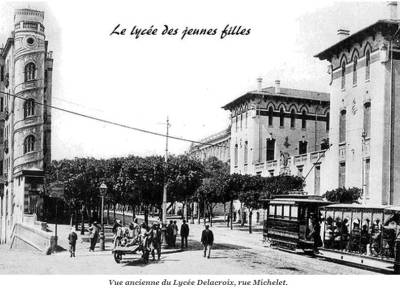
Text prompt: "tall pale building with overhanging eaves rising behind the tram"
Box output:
[[316, 2, 400, 205]]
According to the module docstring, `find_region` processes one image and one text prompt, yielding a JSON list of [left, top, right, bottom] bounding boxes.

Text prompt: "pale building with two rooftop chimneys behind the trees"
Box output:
[[224, 78, 330, 194]]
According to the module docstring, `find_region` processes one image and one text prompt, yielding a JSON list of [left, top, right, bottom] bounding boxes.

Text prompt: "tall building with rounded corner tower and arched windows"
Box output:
[[0, 9, 53, 243]]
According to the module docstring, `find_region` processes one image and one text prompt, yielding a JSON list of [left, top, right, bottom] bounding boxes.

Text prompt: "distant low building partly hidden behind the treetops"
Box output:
[[189, 127, 231, 163]]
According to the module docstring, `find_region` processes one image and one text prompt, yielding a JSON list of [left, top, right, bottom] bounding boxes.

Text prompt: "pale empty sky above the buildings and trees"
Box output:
[[0, 0, 389, 160]]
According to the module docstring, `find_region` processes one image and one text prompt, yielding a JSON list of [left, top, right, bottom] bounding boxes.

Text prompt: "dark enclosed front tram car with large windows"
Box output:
[[263, 194, 331, 251]]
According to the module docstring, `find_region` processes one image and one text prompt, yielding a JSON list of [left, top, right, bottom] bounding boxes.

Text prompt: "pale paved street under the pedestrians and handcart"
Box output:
[[0, 218, 373, 275]]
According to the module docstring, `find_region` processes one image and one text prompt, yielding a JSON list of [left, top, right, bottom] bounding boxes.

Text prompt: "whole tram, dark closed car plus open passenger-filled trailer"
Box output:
[[263, 194, 400, 262]]
